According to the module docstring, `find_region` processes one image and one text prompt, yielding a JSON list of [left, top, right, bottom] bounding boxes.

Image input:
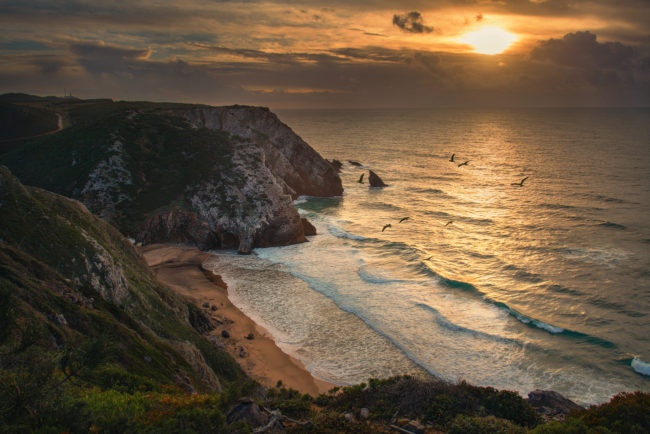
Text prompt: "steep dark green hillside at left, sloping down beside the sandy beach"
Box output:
[[0, 167, 249, 428]]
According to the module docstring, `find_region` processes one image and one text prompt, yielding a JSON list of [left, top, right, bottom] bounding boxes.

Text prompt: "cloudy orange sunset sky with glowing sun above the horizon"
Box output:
[[0, 0, 650, 109]]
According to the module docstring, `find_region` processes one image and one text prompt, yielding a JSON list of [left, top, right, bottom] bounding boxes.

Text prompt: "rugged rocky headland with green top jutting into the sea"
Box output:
[[0, 100, 343, 253]]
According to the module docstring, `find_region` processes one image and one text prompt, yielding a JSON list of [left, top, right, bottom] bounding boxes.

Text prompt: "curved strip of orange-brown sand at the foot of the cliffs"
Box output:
[[140, 244, 335, 396]]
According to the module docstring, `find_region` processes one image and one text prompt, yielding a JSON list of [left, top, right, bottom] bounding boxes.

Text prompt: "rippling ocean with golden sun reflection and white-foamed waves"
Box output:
[[204, 109, 650, 405]]
